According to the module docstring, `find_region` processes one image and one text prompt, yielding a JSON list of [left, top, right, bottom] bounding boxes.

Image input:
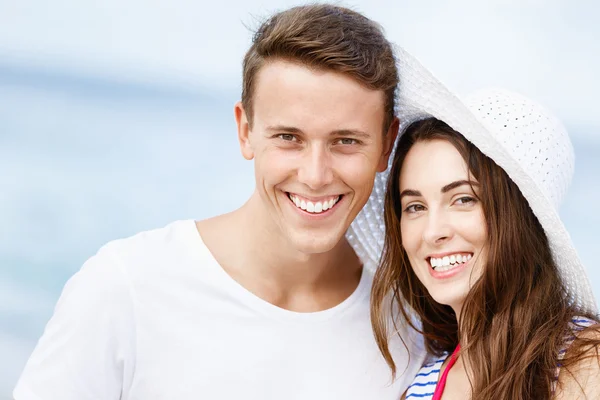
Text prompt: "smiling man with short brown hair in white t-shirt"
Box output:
[[14, 5, 422, 400]]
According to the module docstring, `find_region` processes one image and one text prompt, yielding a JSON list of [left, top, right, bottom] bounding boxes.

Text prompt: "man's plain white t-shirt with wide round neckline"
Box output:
[[13, 220, 425, 400]]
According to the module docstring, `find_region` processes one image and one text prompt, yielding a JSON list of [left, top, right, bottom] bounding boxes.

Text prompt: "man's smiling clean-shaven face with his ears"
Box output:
[[236, 61, 398, 254]]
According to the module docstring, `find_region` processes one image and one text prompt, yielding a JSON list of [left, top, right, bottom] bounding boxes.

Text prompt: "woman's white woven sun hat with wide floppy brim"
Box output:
[[347, 48, 597, 312]]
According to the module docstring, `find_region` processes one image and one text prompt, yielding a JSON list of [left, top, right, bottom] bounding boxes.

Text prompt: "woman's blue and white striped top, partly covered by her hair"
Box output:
[[404, 317, 595, 400]]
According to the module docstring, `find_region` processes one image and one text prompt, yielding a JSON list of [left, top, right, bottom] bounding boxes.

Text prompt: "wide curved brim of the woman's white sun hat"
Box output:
[[347, 47, 597, 313]]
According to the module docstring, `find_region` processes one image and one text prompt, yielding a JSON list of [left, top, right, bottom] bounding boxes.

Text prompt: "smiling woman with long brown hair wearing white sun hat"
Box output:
[[349, 48, 600, 400]]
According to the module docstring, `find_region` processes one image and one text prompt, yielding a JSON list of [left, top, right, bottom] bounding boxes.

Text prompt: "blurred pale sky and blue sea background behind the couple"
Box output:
[[0, 0, 600, 399]]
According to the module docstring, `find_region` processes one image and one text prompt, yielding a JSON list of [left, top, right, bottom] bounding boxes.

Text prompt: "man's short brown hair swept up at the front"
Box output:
[[242, 4, 398, 132]]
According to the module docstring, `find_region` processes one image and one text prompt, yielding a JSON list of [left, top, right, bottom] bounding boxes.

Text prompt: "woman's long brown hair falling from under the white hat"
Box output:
[[371, 118, 600, 400]]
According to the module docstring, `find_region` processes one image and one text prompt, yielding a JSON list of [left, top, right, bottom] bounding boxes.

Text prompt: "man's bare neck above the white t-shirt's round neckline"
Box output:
[[198, 194, 362, 312]]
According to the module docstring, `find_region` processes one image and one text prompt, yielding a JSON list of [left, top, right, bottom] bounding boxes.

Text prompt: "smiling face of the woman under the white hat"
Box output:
[[400, 139, 487, 316]]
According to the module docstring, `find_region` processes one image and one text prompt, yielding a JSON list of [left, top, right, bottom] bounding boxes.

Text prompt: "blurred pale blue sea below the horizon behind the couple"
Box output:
[[0, 65, 600, 398]]
